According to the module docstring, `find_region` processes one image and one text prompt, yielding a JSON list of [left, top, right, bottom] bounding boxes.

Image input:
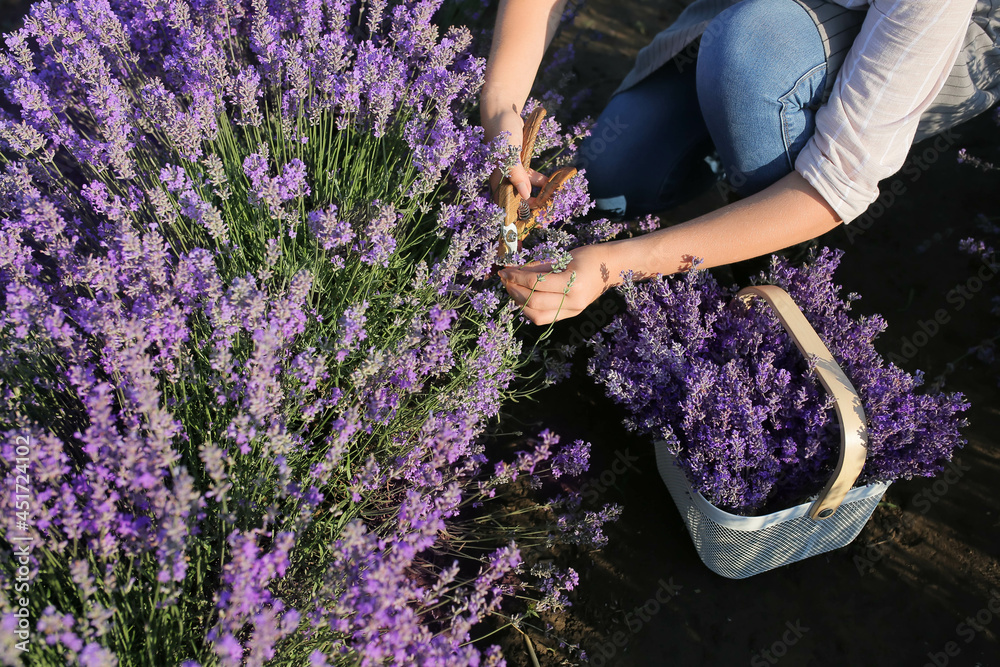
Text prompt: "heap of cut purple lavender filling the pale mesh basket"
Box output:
[[588, 249, 968, 515]]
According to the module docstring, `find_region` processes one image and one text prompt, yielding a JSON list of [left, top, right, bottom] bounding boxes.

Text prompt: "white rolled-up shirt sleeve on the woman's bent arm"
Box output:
[[795, 0, 975, 222]]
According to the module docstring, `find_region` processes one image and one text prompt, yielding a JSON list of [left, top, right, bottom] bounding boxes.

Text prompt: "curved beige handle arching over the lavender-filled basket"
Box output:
[[736, 285, 868, 520]]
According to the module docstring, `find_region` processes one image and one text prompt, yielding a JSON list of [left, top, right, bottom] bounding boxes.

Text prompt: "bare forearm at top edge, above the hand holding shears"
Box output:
[[480, 0, 566, 125]]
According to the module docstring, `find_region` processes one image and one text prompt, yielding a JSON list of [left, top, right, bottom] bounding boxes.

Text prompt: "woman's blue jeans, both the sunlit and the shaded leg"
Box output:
[[578, 0, 848, 215]]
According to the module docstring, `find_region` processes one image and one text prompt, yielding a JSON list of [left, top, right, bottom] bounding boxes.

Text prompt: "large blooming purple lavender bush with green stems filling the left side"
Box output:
[[0, 0, 615, 667]]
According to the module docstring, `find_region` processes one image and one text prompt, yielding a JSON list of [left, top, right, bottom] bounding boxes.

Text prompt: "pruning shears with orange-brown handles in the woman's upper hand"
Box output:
[[497, 107, 576, 264]]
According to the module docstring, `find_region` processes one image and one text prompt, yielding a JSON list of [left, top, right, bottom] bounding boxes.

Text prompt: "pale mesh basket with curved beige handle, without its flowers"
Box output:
[[656, 285, 889, 579]]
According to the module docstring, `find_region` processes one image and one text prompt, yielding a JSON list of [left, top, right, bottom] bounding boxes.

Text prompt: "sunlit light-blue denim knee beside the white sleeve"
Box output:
[[697, 0, 826, 195]]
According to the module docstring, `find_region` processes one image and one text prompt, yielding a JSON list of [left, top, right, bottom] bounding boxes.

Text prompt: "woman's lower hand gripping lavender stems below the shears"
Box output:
[[500, 244, 621, 324]]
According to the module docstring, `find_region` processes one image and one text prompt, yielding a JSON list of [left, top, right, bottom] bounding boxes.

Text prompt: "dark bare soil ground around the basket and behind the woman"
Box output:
[[505, 0, 1000, 667]]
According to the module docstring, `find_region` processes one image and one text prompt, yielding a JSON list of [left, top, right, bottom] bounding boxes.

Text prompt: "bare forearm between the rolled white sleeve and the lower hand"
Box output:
[[606, 171, 840, 284]]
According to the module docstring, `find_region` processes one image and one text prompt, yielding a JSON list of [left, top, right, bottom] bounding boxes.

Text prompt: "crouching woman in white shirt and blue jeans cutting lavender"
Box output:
[[481, 0, 1000, 324]]
